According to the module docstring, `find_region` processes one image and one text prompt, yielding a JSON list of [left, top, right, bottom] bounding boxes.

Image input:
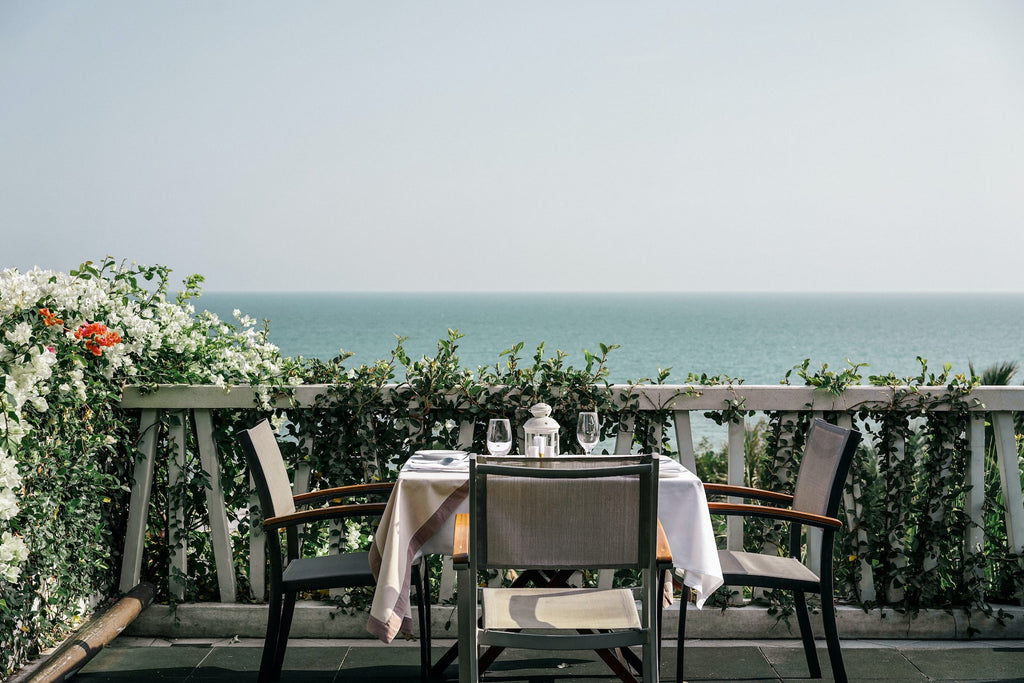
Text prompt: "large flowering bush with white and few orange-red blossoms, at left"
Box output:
[[0, 259, 298, 679]]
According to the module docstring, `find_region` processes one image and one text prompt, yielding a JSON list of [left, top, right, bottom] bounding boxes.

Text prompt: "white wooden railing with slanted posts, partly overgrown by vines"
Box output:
[[121, 385, 1024, 602]]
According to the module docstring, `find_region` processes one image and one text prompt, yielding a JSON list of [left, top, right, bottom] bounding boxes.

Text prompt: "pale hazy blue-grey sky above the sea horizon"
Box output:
[[0, 0, 1024, 292]]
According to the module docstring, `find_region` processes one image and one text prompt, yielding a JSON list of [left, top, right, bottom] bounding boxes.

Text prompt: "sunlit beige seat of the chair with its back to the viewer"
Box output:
[[481, 588, 640, 630]]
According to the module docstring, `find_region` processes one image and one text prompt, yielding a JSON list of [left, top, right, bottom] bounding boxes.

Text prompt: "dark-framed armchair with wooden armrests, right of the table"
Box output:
[[676, 419, 860, 683]]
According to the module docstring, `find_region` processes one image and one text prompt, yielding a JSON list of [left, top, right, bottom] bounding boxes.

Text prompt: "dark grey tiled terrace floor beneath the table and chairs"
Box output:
[[15, 637, 1024, 683]]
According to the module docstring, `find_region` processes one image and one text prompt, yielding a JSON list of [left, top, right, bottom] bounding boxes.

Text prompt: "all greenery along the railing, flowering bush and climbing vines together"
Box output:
[[0, 259, 1024, 677]]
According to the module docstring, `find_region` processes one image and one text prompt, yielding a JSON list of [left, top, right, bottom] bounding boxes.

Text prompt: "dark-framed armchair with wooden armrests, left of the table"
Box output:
[[239, 420, 430, 683]]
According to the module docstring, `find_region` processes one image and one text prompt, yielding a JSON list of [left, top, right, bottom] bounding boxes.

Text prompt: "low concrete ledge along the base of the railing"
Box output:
[[124, 601, 1024, 640]]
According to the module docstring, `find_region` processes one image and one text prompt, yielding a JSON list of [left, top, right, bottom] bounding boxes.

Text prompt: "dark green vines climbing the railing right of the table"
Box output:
[[696, 358, 1024, 618]]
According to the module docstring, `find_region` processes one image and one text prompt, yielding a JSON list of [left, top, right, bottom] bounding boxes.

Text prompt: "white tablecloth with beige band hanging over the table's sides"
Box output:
[[367, 456, 722, 642]]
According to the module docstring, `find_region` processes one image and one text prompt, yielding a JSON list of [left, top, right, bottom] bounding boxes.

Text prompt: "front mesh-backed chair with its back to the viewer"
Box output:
[[454, 456, 672, 683]]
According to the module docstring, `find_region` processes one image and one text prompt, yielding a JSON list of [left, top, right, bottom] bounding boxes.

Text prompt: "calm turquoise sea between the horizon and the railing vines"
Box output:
[[196, 293, 1024, 446]]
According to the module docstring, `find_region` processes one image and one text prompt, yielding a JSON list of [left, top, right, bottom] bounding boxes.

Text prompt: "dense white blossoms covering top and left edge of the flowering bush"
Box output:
[[0, 268, 298, 582]]
